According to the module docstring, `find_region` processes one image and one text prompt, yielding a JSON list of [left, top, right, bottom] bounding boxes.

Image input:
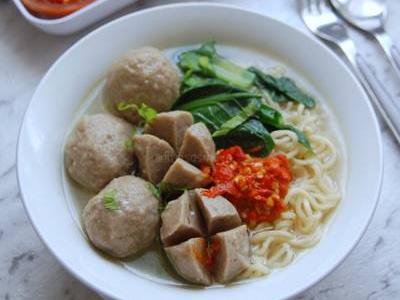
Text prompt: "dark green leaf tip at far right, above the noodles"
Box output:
[[249, 67, 315, 108]]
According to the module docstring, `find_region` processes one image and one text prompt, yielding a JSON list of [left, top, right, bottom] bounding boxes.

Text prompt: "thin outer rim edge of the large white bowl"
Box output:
[[16, 0, 384, 299]]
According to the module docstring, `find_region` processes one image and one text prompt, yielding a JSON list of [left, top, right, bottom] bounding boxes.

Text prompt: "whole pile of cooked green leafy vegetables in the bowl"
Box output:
[[176, 42, 315, 155]]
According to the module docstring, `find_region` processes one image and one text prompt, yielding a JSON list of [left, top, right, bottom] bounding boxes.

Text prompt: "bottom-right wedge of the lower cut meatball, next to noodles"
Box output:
[[212, 225, 250, 283]]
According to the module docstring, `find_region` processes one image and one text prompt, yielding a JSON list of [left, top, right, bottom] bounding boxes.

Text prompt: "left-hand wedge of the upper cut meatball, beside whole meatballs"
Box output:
[[133, 134, 176, 184]]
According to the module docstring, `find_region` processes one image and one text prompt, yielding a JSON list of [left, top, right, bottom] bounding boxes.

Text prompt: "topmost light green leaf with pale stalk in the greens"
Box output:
[[178, 41, 255, 89]]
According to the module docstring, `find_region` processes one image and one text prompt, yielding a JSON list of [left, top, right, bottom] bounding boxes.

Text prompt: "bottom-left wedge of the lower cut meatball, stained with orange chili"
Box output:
[[165, 238, 212, 285]]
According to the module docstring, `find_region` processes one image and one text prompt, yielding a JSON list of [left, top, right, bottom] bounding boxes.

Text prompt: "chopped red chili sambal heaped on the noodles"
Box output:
[[204, 146, 292, 227]]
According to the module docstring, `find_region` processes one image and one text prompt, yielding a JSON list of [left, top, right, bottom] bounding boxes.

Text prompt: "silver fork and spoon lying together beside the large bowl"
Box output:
[[300, 0, 400, 142]]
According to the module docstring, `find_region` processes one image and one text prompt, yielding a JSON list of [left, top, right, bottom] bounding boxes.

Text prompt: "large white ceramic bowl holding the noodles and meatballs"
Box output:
[[18, 4, 382, 300]]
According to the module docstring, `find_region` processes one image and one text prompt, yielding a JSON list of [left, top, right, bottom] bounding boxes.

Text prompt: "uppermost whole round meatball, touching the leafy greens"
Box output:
[[103, 47, 180, 124]]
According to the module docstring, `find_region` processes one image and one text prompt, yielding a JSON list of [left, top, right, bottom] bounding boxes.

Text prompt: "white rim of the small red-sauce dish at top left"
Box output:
[[13, 0, 137, 35]]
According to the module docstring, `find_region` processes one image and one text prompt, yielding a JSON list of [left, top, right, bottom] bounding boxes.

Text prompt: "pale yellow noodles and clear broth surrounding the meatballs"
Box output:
[[64, 42, 346, 285]]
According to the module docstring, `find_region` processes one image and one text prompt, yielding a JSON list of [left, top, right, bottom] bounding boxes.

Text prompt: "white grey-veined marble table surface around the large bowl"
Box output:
[[0, 0, 400, 300]]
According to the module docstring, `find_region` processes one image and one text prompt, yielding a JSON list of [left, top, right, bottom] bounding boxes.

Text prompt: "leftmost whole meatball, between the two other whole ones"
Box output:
[[65, 114, 134, 192]]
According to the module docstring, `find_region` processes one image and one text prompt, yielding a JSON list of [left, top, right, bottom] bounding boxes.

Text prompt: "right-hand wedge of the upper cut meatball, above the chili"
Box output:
[[179, 123, 215, 166]]
